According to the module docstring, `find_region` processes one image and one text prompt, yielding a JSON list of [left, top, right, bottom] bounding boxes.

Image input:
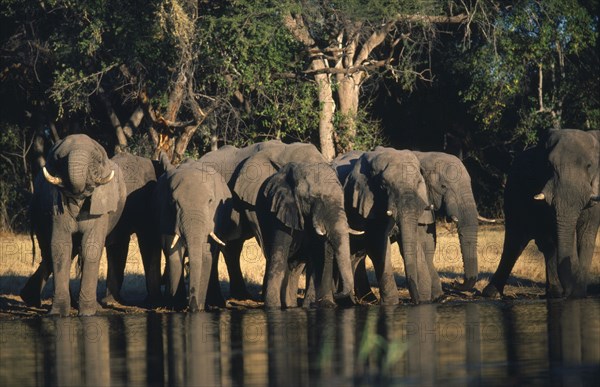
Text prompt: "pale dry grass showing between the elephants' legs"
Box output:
[[0, 223, 600, 306]]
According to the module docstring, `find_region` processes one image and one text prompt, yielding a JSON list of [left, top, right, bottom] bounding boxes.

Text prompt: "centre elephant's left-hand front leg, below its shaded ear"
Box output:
[[265, 230, 291, 308]]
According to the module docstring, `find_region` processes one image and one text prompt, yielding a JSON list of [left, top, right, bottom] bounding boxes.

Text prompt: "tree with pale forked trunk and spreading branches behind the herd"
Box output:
[[283, 0, 466, 159]]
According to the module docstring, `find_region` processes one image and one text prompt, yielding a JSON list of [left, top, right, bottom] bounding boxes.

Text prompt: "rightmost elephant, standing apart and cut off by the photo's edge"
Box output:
[[483, 129, 600, 298]]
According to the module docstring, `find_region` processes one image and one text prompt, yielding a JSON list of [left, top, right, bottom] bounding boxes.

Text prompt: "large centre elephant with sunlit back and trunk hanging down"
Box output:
[[199, 140, 353, 307]]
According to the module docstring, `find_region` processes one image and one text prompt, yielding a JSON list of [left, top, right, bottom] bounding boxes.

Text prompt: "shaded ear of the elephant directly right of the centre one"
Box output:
[[344, 155, 375, 219]]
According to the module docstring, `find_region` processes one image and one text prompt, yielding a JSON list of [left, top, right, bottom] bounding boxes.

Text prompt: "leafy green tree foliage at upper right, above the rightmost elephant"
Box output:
[[456, 0, 600, 139]]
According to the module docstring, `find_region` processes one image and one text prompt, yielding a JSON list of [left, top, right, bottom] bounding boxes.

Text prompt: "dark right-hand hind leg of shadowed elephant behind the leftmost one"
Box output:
[[137, 233, 162, 306]]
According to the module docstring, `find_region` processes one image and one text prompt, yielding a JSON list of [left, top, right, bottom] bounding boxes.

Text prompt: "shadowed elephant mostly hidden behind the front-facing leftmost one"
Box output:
[[20, 153, 164, 306]]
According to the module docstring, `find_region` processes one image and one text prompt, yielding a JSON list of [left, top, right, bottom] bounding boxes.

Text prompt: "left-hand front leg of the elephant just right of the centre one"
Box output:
[[368, 238, 400, 305]]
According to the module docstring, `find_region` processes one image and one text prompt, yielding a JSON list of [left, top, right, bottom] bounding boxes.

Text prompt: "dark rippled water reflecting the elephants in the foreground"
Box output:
[[0, 298, 600, 386]]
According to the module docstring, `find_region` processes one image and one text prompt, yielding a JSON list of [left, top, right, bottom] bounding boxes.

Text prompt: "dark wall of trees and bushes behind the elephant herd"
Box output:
[[0, 0, 600, 231]]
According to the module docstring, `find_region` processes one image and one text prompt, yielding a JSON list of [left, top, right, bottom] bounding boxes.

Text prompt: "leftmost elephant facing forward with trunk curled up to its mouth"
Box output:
[[24, 134, 126, 316]]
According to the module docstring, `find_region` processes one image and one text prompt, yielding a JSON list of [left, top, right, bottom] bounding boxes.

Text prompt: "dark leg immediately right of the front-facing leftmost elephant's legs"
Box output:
[[102, 235, 130, 304]]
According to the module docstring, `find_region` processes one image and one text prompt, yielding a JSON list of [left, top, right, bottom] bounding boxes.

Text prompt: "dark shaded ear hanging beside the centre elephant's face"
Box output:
[[264, 163, 304, 230]]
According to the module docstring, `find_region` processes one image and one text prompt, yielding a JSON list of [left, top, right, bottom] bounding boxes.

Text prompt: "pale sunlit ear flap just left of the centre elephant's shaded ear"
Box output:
[[233, 153, 279, 206]]
